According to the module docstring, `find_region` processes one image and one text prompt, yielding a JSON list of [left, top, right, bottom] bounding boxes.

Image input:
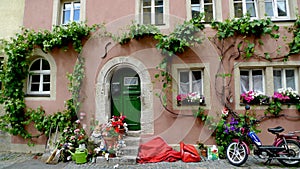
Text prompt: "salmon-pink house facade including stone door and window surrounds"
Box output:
[[4, 0, 300, 153]]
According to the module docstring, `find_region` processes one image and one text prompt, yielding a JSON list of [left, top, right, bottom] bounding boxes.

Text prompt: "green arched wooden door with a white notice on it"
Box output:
[[111, 68, 141, 130]]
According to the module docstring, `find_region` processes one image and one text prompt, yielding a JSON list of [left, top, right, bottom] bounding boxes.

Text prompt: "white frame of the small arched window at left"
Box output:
[[27, 57, 51, 95]]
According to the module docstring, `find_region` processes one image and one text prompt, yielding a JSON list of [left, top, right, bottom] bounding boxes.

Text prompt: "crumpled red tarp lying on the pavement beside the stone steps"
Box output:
[[137, 137, 201, 163]]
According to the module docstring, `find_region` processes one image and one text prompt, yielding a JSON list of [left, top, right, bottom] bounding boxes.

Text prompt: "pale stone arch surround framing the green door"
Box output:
[[95, 56, 154, 134]]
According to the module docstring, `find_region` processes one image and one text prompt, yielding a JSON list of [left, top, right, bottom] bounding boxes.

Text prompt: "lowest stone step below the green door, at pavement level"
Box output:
[[96, 155, 136, 165]]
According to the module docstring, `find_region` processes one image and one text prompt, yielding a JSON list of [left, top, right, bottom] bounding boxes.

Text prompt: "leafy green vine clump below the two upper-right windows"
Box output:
[[211, 15, 279, 60]]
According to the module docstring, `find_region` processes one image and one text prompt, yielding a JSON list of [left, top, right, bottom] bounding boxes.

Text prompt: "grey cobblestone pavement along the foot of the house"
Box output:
[[0, 152, 300, 169]]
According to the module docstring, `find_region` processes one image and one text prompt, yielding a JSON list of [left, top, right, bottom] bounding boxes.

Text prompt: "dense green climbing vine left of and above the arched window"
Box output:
[[0, 22, 101, 139]]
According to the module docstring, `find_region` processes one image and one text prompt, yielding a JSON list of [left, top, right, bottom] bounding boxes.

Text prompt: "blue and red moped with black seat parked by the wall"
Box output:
[[226, 105, 300, 166]]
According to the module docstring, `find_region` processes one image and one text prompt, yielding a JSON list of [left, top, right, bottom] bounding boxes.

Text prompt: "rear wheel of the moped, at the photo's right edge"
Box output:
[[278, 140, 300, 167]]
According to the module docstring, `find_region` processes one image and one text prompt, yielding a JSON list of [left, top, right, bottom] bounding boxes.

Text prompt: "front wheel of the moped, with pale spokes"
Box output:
[[226, 142, 248, 166]]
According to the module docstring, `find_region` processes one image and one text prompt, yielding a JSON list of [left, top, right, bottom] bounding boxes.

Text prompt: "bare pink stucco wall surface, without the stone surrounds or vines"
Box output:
[[15, 0, 300, 147]]
